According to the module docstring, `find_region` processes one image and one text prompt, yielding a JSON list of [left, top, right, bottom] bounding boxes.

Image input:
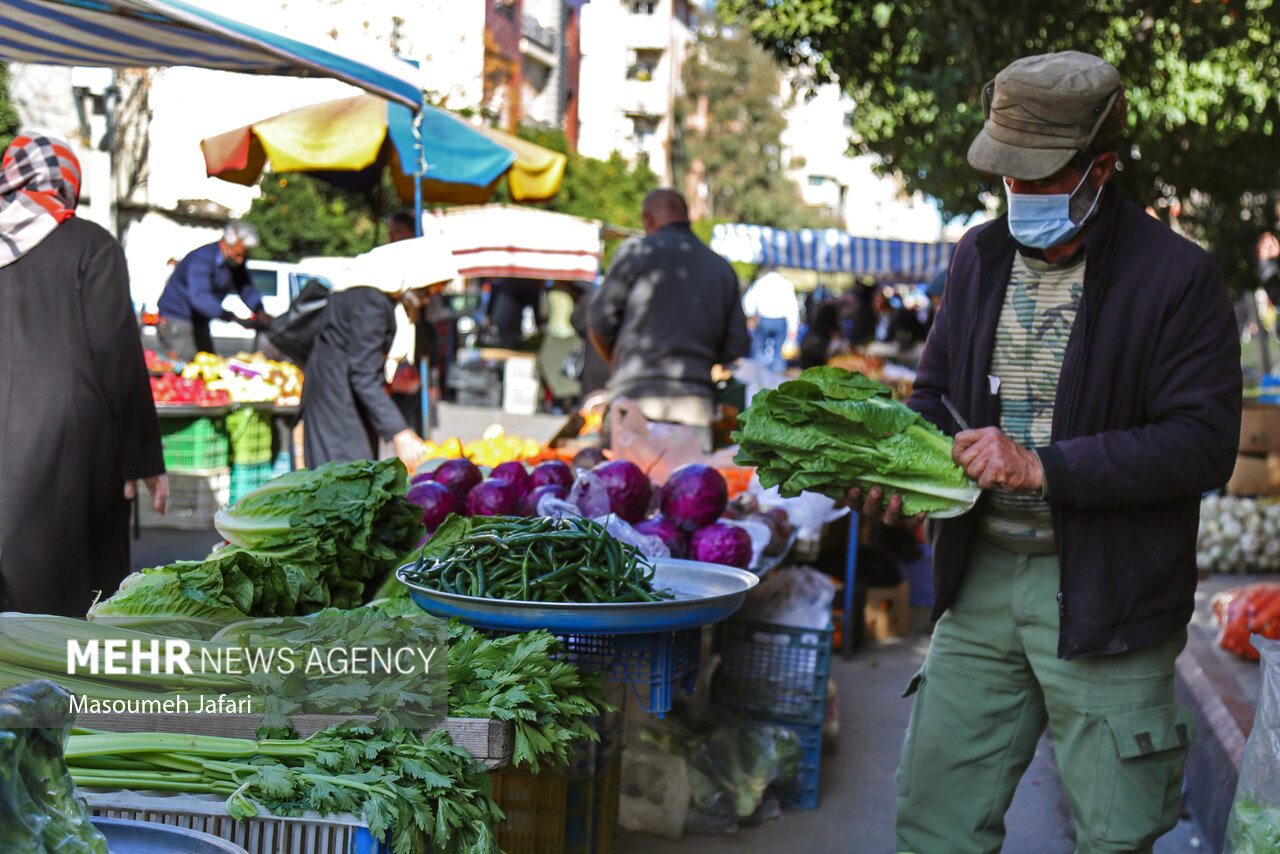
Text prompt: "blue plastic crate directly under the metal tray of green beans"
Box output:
[[561, 629, 701, 714]]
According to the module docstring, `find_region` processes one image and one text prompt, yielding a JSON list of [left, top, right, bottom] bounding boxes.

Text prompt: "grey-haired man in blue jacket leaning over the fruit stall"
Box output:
[[156, 220, 271, 362]]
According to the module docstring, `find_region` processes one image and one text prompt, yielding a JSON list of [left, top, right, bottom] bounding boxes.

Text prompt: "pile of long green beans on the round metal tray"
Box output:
[[403, 516, 673, 604]]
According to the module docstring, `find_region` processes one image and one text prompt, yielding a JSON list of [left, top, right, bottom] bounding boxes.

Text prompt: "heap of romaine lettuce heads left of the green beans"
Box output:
[[90, 460, 424, 629]]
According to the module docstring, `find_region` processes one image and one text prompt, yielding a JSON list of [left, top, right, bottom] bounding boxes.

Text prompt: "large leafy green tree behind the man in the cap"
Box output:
[[718, 0, 1280, 294]]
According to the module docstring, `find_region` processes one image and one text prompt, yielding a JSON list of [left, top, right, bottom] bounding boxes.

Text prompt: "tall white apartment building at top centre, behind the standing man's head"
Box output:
[[577, 0, 695, 184]]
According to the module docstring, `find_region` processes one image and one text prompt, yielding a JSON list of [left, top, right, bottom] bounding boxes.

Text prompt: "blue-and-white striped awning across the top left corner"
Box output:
[[0, 0, 422, 110]]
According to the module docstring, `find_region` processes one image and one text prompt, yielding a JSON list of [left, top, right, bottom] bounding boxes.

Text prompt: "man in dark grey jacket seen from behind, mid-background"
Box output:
[[589, 189, 751, 451]]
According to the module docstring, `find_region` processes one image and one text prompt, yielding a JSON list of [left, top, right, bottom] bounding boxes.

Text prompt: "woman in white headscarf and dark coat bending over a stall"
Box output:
[[301, 234, 458, 472]]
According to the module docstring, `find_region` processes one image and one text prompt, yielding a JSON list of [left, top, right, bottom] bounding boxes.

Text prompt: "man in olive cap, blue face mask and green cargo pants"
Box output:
[[850, 51, 1240, 854]]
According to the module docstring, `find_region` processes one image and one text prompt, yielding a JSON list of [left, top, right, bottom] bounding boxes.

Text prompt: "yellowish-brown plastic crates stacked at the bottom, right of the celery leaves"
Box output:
[[490, 684, 626, 854]]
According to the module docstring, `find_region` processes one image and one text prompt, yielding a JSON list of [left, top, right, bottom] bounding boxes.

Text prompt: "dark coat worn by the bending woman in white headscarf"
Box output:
[[302, 287, 408, 469]]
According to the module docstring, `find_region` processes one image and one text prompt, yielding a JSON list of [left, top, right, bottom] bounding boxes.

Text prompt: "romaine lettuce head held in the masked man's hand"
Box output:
[[733, 367, 980, 519]]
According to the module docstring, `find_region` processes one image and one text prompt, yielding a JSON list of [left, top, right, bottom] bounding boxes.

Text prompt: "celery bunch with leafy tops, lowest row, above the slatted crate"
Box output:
[[67, 723, 503, 854]]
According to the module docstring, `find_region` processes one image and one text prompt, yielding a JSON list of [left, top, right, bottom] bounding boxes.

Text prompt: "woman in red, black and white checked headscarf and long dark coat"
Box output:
[[0, 134, 169, 616]]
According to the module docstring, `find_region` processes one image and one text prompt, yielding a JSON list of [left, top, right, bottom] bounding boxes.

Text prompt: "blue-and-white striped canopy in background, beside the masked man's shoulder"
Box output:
[[712, 223, 952, 282]]
